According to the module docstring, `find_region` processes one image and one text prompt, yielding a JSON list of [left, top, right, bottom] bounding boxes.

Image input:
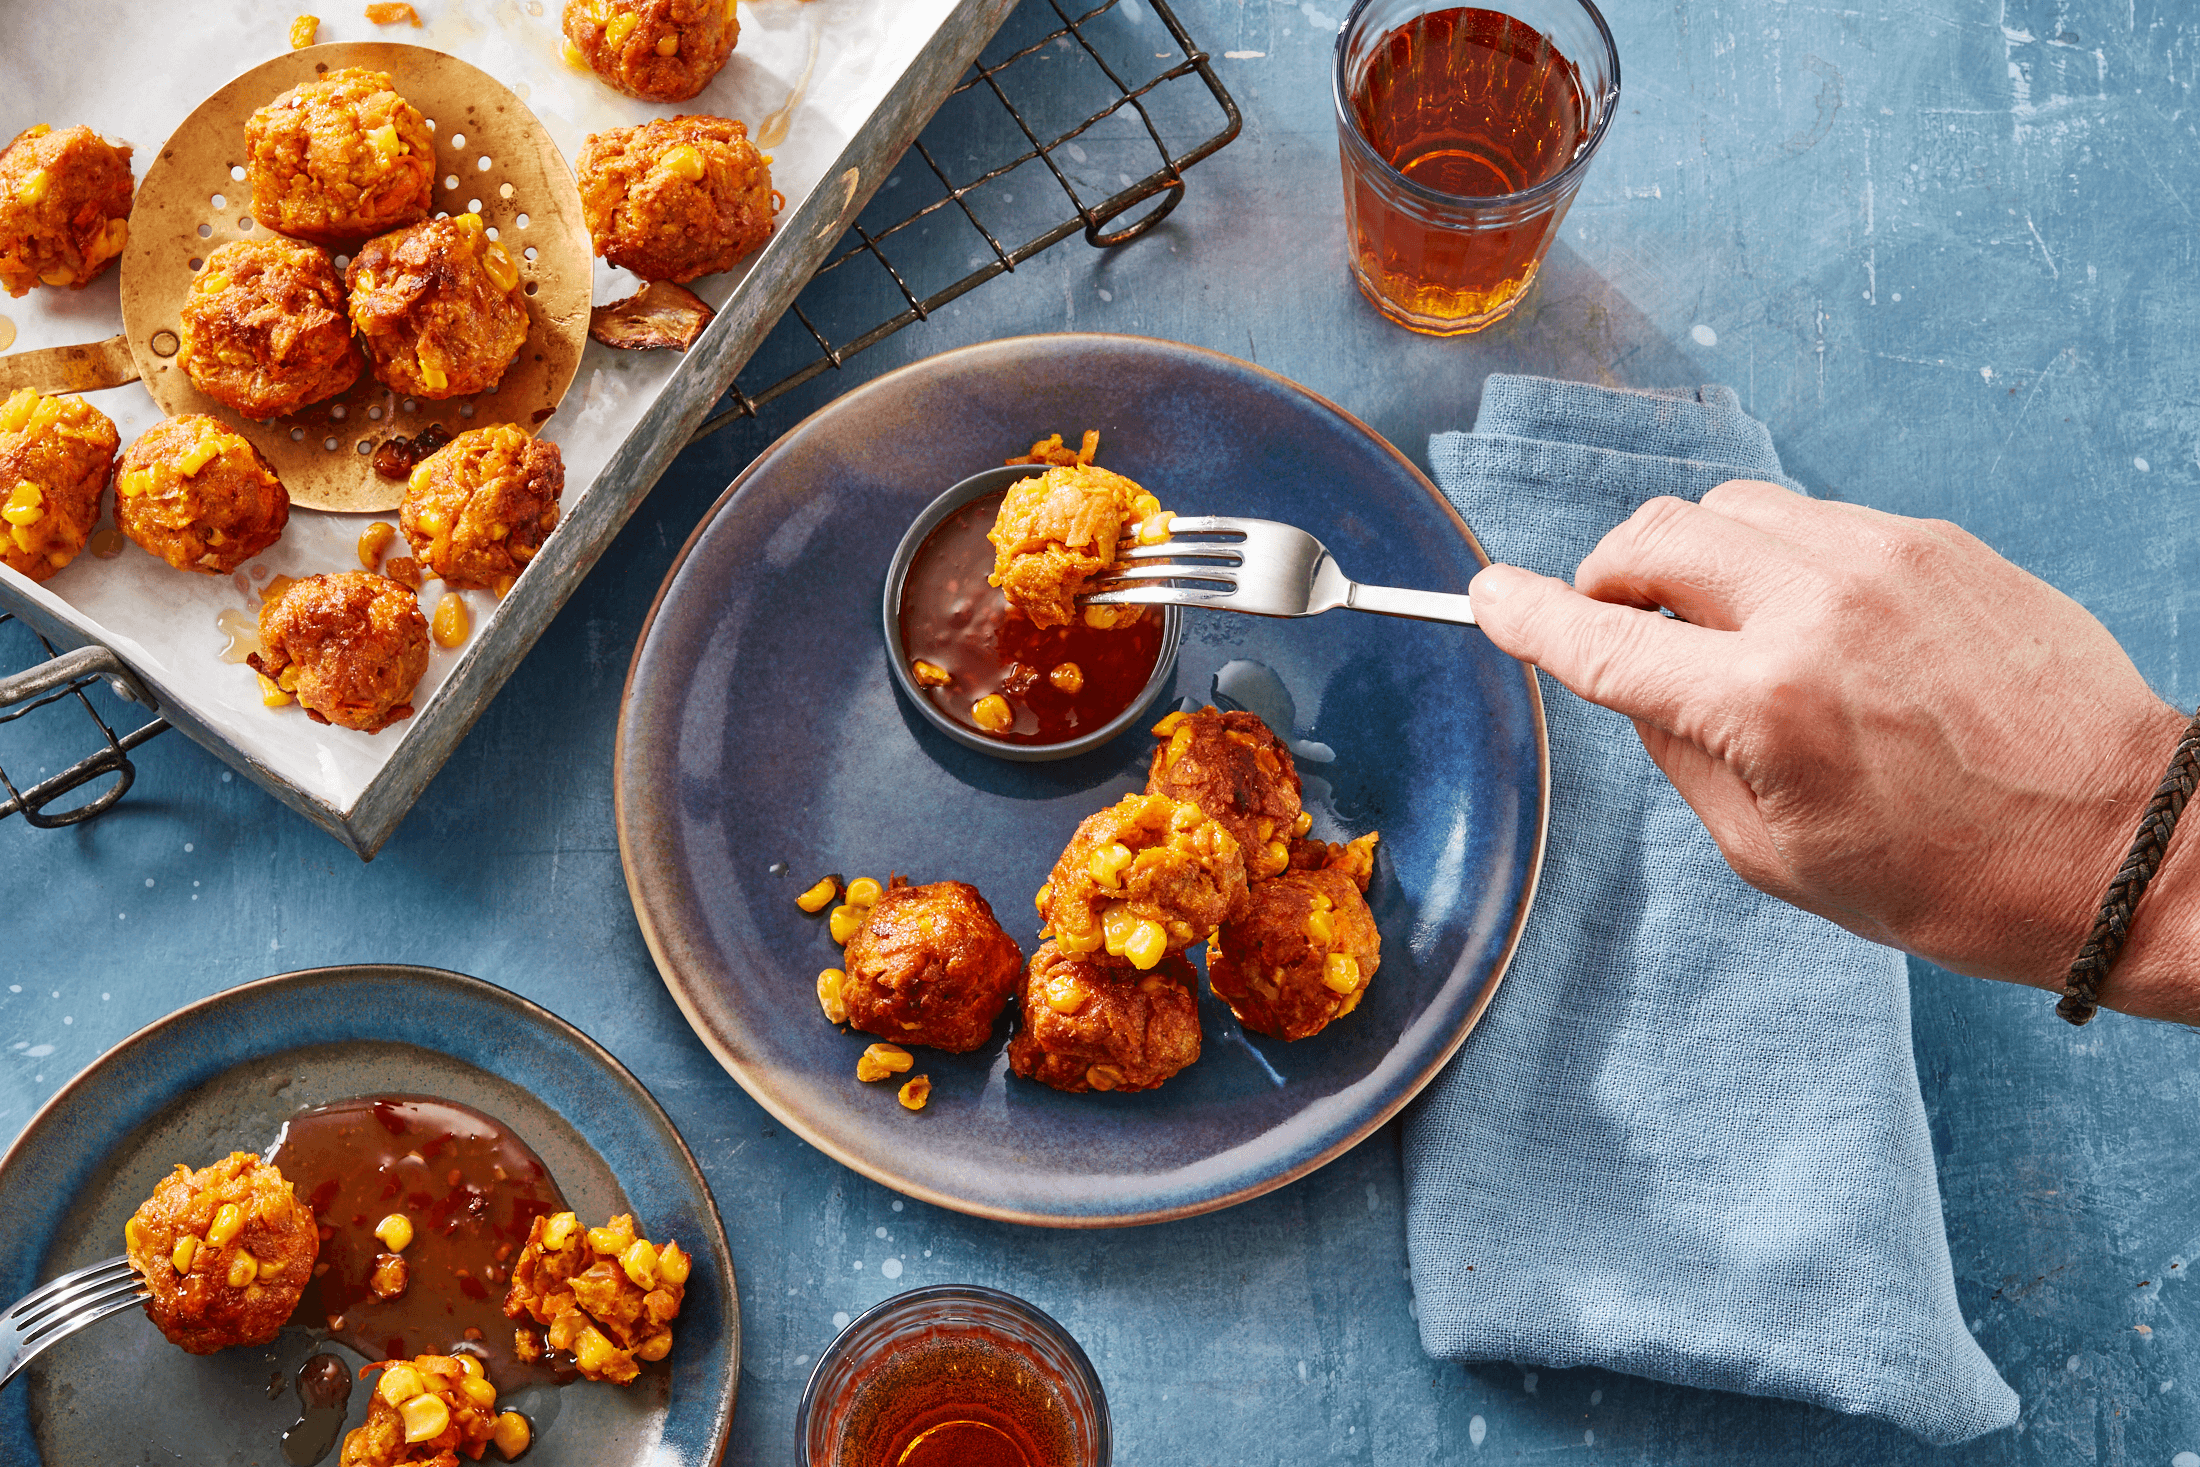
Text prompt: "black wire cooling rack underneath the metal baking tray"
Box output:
[[0, 0, 1243, 829]]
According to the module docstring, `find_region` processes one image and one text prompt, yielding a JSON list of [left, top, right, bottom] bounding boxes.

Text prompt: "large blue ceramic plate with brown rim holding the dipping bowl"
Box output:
[[616, 337, 1549, 1225]]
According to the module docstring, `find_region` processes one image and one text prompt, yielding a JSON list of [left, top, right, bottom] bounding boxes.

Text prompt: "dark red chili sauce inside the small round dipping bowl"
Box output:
[[900, 490, 1162, 743]]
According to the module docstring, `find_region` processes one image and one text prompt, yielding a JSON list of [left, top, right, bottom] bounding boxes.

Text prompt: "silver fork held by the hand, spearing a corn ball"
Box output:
[[1078, 515, 1474, 627]]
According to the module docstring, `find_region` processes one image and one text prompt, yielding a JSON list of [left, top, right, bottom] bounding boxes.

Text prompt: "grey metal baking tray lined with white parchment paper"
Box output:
[[0, 0, 1014, 858]]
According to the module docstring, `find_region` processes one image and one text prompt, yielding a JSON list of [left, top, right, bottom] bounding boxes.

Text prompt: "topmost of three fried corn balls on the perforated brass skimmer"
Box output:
[[244, 66, 436, 244]]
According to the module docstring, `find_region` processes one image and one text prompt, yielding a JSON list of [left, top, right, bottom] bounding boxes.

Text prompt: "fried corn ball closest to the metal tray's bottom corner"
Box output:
[[244, 570, 427, 732]]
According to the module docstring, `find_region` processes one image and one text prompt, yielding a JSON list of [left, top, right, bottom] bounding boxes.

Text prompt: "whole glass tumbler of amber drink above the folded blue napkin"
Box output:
[[1335, 0, 1619, 337]]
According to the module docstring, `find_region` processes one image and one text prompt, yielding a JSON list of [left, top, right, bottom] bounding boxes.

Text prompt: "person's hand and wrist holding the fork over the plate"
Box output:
[[1472, 479, 2200, 1021]]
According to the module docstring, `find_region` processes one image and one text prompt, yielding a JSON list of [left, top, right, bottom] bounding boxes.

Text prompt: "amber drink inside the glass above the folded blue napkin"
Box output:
[[1346, 7, 1588, 326]]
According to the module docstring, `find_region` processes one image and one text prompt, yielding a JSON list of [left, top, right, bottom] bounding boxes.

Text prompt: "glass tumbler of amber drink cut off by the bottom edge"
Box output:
[[801, 1284, 1113, 1467]]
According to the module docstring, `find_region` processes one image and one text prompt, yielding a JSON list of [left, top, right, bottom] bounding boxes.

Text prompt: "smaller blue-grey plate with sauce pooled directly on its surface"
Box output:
[[0, 966, 741, 1467]]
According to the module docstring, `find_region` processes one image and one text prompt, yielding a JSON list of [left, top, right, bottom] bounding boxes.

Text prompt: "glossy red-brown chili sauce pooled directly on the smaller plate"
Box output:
[[271, 1095, 565, 1394]]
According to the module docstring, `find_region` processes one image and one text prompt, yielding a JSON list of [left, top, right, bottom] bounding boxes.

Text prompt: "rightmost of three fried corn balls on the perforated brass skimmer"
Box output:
[[343, 213, 528, 398]]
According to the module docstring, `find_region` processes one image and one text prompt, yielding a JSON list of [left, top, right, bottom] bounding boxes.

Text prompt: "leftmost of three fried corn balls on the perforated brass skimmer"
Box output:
[[176, 240, 365, 422]]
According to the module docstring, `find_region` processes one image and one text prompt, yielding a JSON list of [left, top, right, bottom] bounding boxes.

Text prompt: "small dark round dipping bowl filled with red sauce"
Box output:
[[884, 464, 1184, 763]]
